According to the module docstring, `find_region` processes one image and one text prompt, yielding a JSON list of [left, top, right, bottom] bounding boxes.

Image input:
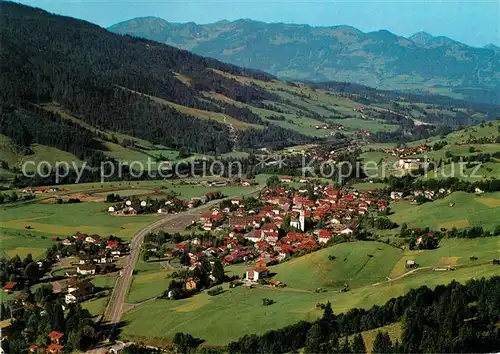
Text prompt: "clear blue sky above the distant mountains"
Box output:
[[13, 0, 500, 46]]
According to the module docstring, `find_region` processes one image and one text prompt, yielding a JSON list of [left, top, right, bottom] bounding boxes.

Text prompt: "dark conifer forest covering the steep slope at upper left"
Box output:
[[0, 2, 313, 164]]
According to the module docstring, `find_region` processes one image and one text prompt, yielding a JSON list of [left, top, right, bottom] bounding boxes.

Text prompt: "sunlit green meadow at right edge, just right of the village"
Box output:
[[390, 192, 500, 231]]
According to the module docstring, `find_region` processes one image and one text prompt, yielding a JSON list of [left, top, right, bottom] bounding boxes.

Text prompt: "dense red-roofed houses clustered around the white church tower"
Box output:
[[170, 183, 388, 278]]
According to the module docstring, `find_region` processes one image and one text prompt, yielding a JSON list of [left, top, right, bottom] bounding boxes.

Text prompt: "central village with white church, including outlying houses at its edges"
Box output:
[[139, 176, 388, 287]]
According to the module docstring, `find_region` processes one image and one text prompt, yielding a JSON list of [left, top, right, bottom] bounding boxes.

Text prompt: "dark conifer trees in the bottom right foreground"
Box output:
[[228, 277, 500, 353]]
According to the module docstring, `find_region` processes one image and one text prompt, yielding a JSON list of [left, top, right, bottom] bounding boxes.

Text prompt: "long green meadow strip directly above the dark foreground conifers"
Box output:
[[122, 265, 498, 345]]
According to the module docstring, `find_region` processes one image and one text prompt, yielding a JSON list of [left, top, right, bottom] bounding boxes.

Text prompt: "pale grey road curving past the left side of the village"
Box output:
[[104, 189, 258, 323]]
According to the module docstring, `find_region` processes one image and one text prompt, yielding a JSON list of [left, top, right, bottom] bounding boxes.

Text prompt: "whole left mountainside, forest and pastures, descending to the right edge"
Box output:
[[0, 2, 500, 178]]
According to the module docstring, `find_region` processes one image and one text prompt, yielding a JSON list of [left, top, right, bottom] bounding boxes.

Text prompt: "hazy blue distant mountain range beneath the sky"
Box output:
[[109, 17, 500, 104]]
